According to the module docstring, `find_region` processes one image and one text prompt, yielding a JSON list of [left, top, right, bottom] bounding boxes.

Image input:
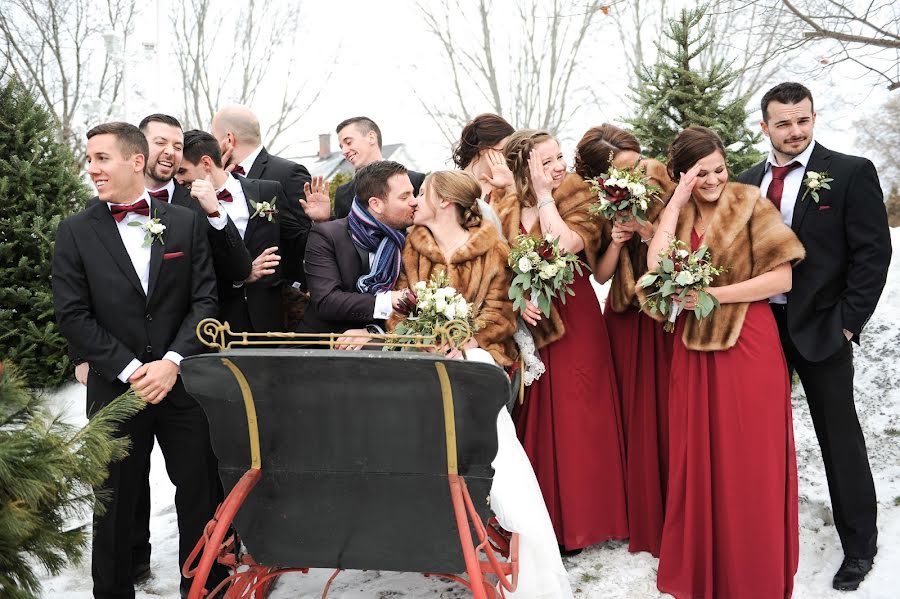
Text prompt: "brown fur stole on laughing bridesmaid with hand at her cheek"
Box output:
[[491, 173, 600, 348]]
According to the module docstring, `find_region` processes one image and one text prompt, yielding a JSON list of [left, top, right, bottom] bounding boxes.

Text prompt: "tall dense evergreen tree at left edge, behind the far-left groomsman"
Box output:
[[0, 78, 88, 387]]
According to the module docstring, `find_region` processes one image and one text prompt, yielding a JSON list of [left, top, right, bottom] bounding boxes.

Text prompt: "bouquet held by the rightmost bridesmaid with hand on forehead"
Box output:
[[637, 239, 727, 333]]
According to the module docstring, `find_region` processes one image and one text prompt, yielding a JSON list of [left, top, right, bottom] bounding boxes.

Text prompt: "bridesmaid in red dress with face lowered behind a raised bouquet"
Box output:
[[575, 123, 675, 557]]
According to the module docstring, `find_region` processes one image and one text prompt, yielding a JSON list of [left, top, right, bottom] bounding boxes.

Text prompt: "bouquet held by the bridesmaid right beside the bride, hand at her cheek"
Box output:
[[509, 233, 581, 316]]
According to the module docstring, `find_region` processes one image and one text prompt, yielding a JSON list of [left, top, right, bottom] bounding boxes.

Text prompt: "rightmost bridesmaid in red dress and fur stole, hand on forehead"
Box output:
[[641, 127, 804, 599]]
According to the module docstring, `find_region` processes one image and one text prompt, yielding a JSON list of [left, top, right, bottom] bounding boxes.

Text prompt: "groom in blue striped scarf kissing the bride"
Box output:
[[298, 160, 414, 338]]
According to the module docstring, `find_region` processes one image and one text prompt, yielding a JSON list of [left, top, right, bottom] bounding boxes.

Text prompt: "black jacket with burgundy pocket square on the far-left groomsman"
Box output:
[[53, 200, 217, 412]]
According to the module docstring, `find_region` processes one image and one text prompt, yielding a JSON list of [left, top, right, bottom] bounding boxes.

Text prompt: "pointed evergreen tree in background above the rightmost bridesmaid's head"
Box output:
[[628, 5, 763, 175]]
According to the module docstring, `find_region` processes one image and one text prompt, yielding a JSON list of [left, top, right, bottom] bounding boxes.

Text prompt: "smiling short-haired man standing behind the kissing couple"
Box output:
[[334, 116, 425, 218]]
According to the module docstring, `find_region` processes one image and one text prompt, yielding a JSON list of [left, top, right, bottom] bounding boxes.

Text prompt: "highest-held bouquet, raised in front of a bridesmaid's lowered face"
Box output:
[[588, 154, 660, 223]]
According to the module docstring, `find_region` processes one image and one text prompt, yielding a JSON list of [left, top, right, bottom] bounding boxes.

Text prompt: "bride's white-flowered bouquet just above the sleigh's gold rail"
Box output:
[[394, 271, 480, 345]]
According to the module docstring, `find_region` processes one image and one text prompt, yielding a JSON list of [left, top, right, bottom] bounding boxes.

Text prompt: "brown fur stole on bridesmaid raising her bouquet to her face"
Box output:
[[598, 158, 677, 312]]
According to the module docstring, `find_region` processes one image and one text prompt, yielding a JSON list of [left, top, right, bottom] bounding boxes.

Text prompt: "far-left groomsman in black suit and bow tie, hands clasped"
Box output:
[[53, 123, 219, 599]]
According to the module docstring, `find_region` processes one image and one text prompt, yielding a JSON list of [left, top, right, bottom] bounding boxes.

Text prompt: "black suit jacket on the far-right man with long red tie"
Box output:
[[738, 143, 891, 362]]
